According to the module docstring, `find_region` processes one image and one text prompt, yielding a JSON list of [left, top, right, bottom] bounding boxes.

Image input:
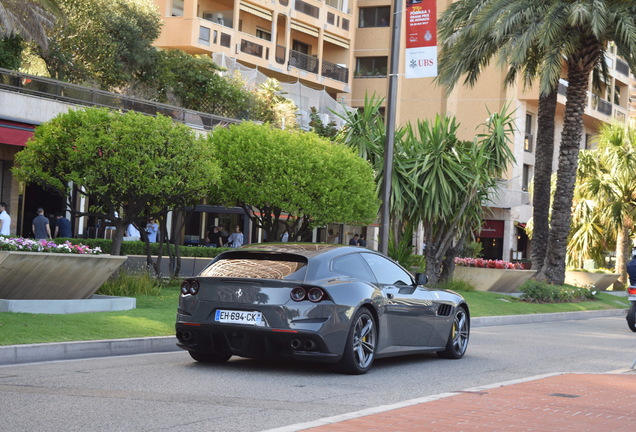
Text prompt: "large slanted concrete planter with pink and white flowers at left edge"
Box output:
[[0, 251, 126, 300]]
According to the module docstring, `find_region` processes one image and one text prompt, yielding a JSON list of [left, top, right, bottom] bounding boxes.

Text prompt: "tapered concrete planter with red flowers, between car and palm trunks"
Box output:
[[453, 266, 535, 293]]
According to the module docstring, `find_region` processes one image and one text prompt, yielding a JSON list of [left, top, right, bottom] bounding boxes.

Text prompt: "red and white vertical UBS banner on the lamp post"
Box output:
[[405, 0, 437, 78]]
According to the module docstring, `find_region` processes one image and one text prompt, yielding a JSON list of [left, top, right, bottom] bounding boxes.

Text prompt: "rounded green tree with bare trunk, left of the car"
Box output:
[[13, 108, 218, 255]]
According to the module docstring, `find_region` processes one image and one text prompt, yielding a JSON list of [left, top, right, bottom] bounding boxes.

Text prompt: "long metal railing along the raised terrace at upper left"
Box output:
[[0, 68, 240, 130]]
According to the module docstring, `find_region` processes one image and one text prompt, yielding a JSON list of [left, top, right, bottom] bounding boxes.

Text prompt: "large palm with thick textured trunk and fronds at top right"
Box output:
[[440, 0, 636, 284]]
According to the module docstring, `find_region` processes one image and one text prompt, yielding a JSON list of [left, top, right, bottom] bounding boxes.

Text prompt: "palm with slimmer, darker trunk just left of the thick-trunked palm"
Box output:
[[438, 0, 559, 270]]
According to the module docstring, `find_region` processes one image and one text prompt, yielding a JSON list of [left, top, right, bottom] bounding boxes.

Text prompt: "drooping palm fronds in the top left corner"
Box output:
[[0, 0, 62, 50]]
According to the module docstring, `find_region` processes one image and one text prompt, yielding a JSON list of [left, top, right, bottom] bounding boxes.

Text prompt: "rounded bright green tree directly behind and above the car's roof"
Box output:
[[210, 122, 378, 241]]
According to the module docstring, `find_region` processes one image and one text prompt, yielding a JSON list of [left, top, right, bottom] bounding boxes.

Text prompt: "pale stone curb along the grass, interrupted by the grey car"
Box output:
[[0, 309, 626, 366]]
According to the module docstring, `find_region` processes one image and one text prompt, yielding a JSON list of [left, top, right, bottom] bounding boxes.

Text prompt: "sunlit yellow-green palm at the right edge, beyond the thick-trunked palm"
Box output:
[[571, 123, 636, 285]]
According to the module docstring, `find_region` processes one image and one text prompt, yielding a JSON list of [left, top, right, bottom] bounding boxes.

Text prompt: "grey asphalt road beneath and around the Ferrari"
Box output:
[[0, 317, 636, 432]]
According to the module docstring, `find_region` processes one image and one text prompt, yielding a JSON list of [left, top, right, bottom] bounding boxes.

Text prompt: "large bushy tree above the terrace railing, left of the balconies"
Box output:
[[40, 0, 161, 90]]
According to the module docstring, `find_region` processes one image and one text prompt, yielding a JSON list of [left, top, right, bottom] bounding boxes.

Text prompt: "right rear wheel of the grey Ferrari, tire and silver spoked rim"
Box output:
[[338, 308, 378, 375]]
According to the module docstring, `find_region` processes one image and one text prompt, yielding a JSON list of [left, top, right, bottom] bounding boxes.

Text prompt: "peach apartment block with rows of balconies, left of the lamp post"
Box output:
[[154, 0, 354, 126]]
